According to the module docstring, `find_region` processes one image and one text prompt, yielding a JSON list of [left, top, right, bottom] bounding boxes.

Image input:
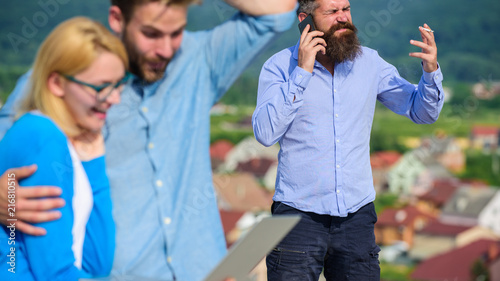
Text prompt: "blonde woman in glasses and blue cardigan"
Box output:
[[0, 17, 128, 281]]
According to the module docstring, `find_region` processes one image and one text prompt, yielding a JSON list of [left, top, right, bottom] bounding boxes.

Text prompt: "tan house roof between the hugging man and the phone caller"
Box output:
[[213, 173, 273, 212]]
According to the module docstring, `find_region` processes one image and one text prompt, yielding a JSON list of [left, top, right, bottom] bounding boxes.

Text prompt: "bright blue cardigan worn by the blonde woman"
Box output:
[[0, 113, 115, 281]]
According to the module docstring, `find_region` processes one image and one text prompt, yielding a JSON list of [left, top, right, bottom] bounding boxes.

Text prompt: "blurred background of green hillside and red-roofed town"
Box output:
[[0, 0, 500, 281]]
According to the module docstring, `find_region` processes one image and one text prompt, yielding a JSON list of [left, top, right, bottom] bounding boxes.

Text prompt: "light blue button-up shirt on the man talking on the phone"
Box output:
[[252, 43, 444, 217]]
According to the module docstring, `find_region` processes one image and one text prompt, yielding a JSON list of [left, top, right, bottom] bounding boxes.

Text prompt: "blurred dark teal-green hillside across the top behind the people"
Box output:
[[0, 0, 500, 102]]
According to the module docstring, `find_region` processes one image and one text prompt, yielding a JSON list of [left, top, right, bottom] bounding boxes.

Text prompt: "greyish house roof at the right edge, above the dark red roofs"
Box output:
[[442, 186, 497, 218]]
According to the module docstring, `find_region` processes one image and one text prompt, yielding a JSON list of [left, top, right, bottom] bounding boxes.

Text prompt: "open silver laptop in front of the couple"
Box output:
[[204, 215, 300, 281]]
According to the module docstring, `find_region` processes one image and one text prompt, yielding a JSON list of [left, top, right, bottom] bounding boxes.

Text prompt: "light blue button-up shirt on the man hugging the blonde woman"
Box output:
[[0, 11, 295, 281]]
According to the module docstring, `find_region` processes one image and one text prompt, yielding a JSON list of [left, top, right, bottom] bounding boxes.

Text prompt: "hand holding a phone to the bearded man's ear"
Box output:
[[298, 16, 326, 73]]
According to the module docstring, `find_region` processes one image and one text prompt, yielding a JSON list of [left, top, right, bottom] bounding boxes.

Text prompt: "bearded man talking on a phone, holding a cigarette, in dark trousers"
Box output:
[[252, 0, 444, 281]]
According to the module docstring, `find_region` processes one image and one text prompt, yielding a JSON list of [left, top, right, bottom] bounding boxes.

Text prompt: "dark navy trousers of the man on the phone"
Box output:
[[266, 202, 380, 281]]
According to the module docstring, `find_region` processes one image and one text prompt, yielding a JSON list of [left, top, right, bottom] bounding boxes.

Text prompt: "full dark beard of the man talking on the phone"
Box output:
[[323, 22, 361, 63]]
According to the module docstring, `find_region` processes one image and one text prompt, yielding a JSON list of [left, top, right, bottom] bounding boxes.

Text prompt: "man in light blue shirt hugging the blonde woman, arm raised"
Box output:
[[0, 0, 297, 281]]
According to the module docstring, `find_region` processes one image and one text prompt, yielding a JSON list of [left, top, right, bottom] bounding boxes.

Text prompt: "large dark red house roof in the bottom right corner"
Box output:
[[411, 240, 498, 281]]
